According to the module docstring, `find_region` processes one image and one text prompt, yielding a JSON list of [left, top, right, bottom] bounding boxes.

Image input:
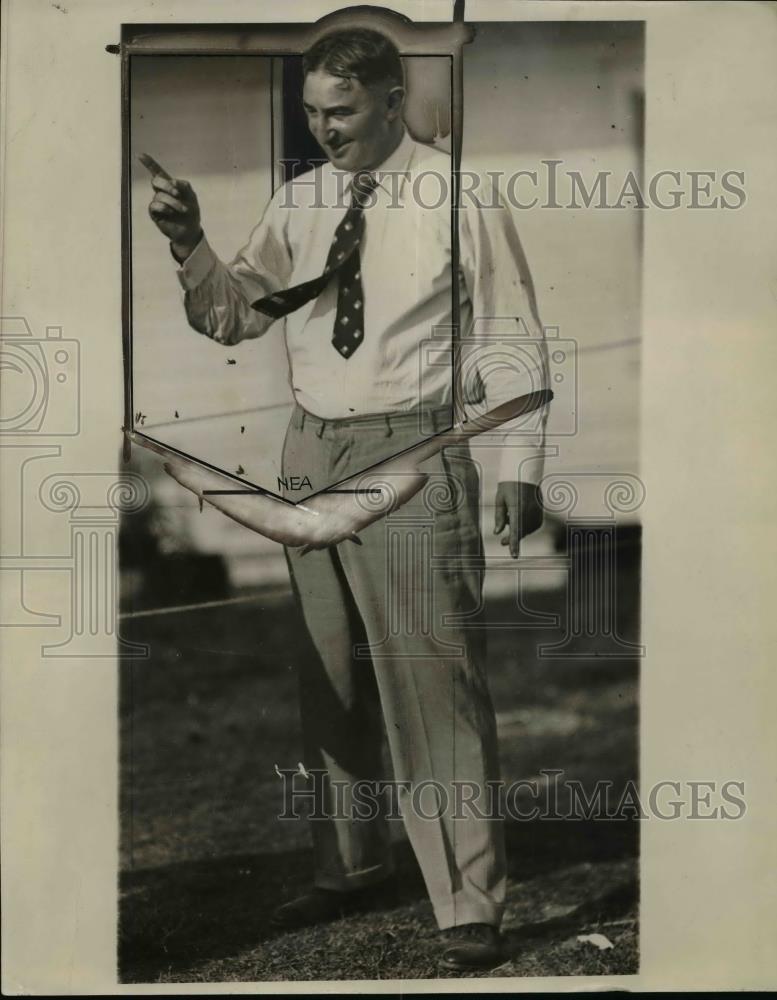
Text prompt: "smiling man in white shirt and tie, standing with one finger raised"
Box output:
[[144, 29, 546, 969]]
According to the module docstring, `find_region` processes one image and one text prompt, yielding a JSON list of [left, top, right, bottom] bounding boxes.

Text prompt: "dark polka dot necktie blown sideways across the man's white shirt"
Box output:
[[252, 171, 377, 358]]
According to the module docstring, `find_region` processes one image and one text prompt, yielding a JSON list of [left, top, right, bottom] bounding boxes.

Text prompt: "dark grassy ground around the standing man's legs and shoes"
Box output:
[[119, 560, 639, 982]]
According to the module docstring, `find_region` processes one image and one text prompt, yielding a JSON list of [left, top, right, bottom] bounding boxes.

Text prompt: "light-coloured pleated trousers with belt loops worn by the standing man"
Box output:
[[283, 407, 506, 928]]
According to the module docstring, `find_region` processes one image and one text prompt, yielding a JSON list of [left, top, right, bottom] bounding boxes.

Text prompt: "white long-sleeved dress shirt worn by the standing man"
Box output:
[[178, 132, 548, 483]]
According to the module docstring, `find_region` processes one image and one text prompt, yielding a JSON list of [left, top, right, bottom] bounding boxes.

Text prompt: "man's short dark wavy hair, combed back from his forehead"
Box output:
[[302, 28, 404, 87]]
